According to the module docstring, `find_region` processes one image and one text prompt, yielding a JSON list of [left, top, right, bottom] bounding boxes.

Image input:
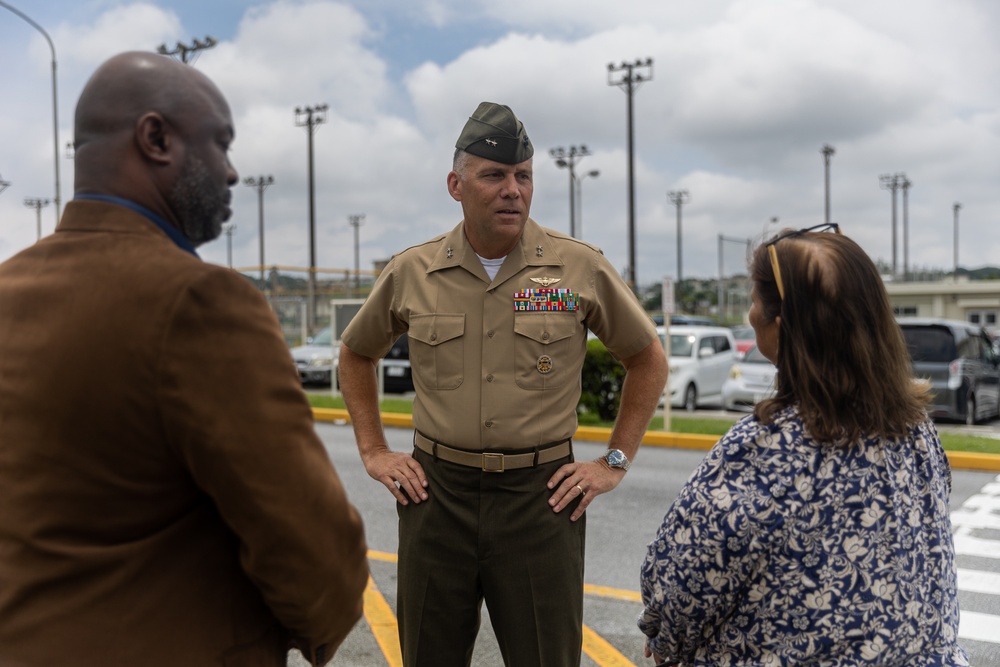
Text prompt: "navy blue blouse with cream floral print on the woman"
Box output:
[[639, 407, 969, 667]]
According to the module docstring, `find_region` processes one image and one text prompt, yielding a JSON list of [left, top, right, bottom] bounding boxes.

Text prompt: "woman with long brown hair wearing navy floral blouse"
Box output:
[[639, 224, 968, 667]]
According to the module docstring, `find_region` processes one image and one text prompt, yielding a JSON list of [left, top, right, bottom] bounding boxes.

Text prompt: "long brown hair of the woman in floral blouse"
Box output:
[[750, 230, 927, 444]]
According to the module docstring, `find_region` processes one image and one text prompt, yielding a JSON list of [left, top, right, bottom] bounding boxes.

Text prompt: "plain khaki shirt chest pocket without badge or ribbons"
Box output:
[[410, 313, 465, 389]]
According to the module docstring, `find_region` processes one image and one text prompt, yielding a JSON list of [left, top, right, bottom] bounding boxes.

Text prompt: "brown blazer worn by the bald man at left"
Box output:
[[0, 201, 368, 667]]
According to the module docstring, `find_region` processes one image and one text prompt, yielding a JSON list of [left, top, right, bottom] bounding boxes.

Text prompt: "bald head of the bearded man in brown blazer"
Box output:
[[74, 51, 236, 245]]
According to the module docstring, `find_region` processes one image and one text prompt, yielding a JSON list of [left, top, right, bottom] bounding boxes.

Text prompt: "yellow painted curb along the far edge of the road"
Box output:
[[313, 408, 1000, 473]]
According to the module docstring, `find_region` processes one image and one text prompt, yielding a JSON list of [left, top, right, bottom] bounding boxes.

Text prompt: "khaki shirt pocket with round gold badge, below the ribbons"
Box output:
[[514, 311, 586, 389]]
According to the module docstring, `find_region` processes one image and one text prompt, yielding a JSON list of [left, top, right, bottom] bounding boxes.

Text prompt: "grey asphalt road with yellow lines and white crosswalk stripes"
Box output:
[[288, 423, 1000, 667]]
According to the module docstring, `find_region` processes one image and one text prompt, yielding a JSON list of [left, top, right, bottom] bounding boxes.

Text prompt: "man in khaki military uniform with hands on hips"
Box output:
[[340, 102, 667, 667]]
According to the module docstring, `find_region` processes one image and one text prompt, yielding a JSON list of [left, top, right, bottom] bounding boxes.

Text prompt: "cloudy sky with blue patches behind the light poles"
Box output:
[[0, 0, 1000, 284]]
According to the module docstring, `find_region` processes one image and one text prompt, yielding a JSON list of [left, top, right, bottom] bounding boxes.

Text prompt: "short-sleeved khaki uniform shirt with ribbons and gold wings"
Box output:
[[343, 219, 656, 450]]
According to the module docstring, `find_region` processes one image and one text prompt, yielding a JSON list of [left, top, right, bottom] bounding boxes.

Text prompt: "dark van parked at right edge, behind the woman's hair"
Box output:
[[897, 317, 1000, 424]]
